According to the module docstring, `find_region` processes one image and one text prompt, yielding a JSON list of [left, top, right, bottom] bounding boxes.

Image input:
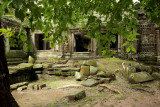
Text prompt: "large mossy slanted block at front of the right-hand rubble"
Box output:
[[128, 72, 154, 83]]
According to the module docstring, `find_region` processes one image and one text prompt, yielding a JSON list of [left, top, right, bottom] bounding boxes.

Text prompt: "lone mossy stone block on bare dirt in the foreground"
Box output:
[[66, 90, 86, 101]]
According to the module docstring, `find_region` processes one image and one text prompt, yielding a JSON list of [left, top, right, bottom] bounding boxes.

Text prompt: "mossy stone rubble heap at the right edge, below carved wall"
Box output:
[[123, 63, 160, 83]]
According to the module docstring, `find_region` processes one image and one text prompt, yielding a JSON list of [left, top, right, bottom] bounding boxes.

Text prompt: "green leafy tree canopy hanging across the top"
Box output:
[[0, 0, 160, 55]]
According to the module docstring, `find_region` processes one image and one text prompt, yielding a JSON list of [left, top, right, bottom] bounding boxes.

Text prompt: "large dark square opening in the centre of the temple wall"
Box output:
[[75, 35, 91, 52]]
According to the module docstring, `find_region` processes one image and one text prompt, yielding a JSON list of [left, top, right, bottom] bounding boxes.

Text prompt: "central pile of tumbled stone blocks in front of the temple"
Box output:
[[75, 60, 116, 87]]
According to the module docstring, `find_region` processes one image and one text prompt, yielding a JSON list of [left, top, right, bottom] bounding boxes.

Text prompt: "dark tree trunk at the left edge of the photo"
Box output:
[[0, 20, 18, 107]]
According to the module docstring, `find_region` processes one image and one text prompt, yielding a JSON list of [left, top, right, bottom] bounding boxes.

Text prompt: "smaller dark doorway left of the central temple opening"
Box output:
[[35, 34, 50, 50]]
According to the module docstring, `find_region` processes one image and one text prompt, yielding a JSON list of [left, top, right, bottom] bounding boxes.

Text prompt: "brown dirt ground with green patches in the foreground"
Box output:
[[12, 58, 160, 107]]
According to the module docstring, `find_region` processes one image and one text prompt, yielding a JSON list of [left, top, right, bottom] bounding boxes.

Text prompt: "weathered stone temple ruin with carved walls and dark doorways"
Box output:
[[1, 7, 160, 91]]
